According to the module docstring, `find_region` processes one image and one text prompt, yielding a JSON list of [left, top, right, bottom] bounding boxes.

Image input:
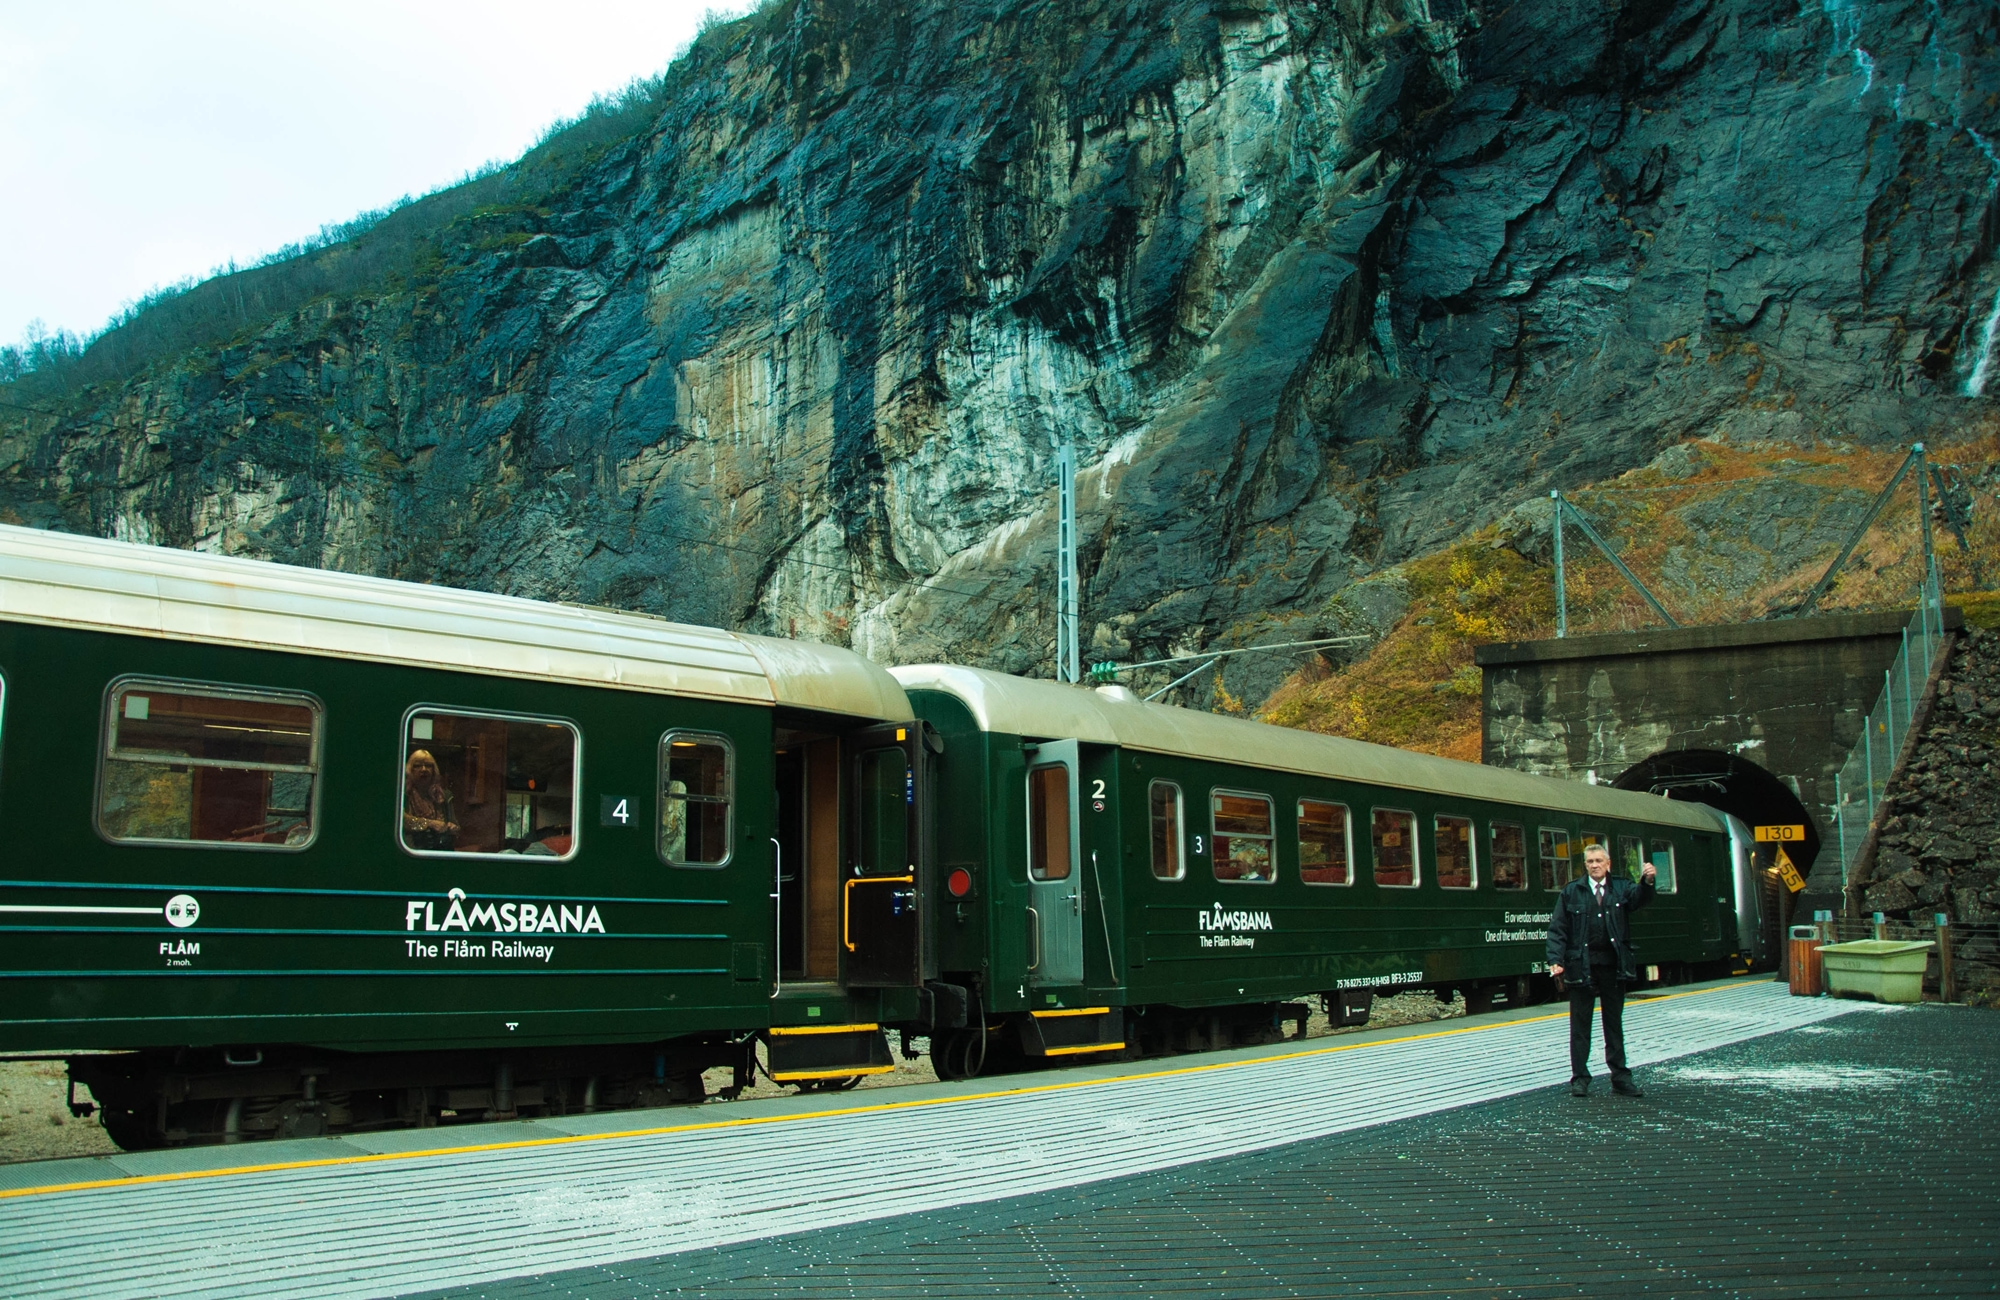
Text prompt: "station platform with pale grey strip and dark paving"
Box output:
[[0, 980, 2000, 1298]]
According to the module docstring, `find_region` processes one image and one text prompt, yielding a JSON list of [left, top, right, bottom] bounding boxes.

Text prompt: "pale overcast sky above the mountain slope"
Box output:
[[0, 0, 746, 344]]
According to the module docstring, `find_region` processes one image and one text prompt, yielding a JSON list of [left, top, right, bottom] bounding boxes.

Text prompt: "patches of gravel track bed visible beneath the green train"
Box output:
[[0, 992, 1466, 1164]]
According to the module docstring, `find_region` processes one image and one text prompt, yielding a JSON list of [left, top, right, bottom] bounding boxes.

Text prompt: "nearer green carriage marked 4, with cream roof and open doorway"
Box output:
[[0, 528, 920, 1146]]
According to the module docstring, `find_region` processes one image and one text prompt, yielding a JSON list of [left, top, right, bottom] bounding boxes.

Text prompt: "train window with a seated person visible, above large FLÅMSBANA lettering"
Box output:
[[398, 708, 580, 858]]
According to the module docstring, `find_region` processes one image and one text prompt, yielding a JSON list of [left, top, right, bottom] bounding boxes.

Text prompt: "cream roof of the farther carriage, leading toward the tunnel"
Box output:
[[890, 664, 1724, 830]]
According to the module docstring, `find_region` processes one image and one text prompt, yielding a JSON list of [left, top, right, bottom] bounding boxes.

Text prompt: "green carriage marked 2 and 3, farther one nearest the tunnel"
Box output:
[[892, 666, 1754, 1072]]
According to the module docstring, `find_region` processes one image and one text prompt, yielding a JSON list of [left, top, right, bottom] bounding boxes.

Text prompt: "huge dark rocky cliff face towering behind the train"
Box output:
[[0, 0, 2000, 694]]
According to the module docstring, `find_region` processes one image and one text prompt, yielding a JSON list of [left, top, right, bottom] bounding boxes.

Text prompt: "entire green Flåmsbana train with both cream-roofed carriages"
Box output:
[[0, 526, 1760, 1148]]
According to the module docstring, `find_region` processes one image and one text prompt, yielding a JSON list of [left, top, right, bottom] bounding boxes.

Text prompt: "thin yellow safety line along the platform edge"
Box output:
[[0, 980, 1770, 1200]]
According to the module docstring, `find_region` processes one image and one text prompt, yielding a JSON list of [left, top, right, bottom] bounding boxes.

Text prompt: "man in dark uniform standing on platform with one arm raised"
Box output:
[[1548, 844, 1656, 1096]]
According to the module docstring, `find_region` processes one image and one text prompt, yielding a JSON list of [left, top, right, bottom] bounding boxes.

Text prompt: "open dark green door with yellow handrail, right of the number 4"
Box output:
[[840, 722, 930, 988]]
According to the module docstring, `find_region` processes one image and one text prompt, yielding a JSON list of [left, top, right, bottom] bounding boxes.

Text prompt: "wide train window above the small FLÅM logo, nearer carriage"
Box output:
[[98, 680, 322, 848]]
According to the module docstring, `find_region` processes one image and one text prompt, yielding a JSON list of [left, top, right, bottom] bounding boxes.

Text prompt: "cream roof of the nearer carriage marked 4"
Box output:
[[0, 526, 912, 722]]
